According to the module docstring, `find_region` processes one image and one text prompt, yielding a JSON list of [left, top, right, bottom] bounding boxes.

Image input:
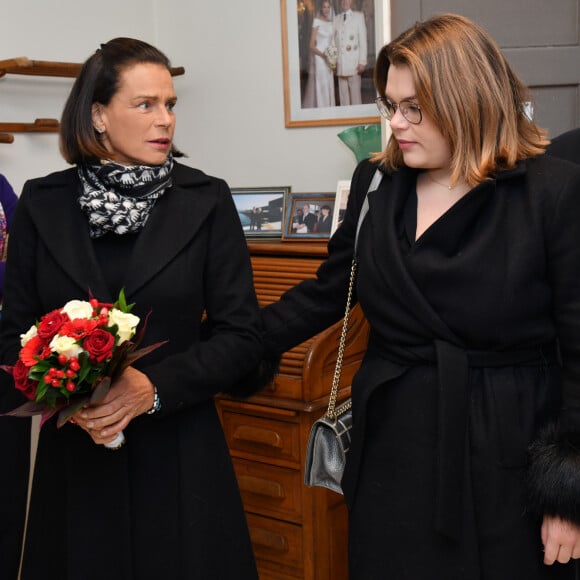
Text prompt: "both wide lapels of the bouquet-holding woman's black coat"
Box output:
[[26, 164, 215, 301]]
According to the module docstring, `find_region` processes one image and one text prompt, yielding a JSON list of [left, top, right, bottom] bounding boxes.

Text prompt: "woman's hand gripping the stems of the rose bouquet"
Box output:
[[73, 367, 155, 444]]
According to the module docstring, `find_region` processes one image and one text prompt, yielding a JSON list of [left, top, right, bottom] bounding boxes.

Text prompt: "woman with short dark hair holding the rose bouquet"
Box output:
[[0, 38, 262, 580]]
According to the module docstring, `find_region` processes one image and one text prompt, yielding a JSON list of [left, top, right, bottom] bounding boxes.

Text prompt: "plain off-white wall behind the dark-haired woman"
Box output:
[[0, 0, 370, 193]]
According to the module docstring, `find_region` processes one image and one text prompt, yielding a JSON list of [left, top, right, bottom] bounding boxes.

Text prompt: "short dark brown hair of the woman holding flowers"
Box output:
[[60, 38, 182, 164]]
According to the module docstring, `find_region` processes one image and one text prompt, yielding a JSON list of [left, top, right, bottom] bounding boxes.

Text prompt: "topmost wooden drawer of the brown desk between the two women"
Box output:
[[222, 409, 301, 468]]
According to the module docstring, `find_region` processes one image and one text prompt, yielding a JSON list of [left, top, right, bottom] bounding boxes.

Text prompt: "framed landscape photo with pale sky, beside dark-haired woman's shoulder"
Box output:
[[231, 186, 290, 238]]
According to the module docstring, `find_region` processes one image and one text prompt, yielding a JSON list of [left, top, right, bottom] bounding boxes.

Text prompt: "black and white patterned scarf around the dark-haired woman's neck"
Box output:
[[78, 155, 173, 238]]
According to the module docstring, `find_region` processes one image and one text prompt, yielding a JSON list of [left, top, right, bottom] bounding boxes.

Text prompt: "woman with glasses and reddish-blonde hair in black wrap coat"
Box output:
[[264, 14, 580, 580]]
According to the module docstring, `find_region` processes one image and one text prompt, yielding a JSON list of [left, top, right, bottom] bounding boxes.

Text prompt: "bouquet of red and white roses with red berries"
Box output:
[[1, 290, 164, 448]]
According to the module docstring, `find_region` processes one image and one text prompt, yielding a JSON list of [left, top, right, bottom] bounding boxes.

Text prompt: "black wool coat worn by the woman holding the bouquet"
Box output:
[[0, 163, 262, 580]]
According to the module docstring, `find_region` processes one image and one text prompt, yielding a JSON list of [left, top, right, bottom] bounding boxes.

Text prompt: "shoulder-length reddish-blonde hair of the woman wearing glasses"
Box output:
[[374, 14, 549, 186]]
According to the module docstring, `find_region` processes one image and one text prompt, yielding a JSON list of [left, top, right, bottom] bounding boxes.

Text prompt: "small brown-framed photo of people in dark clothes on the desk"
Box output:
[[282, 193, 335, 240]]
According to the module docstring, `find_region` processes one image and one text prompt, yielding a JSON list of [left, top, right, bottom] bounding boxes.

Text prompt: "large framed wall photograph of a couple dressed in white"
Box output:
[[280, 0, 388, 127]]
